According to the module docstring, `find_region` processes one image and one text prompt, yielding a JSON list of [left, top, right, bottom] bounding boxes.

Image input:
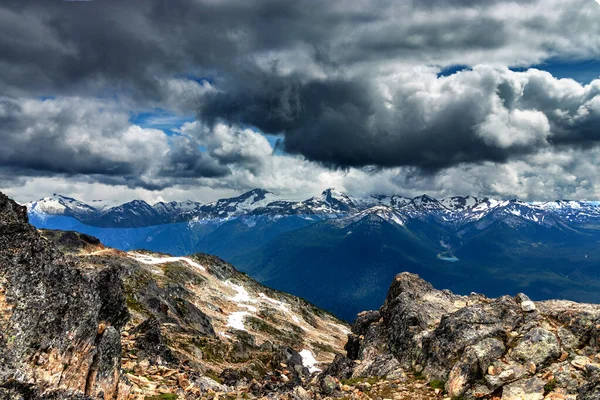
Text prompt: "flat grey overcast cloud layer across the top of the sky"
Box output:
[[0, 0, 594, 96]]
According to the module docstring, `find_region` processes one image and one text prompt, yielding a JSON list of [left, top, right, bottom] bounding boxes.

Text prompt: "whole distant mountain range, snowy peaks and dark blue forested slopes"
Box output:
[[27, 189, 600, 320]]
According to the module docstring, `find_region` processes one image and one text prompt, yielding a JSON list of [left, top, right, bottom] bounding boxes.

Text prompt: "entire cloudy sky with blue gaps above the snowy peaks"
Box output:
[[0, 0, 600, 203]]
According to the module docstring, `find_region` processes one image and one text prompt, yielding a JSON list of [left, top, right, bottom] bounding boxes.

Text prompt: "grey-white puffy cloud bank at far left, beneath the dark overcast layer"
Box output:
[[0, 97, 236, 189]]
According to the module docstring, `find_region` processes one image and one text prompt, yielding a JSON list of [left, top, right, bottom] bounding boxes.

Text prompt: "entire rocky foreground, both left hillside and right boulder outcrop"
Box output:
[[0, 194, 600, 400]]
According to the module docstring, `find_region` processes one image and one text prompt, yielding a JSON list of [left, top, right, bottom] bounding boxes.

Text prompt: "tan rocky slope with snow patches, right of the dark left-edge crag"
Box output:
[[53, 238, 349, 399]]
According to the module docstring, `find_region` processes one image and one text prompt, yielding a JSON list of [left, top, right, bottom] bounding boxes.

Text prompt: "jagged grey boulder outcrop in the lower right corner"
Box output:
[[340, 273, 600, 400]]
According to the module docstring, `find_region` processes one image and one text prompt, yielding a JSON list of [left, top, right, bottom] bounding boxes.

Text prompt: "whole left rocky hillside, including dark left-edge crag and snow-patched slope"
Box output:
[[0, 195, 349, 399]]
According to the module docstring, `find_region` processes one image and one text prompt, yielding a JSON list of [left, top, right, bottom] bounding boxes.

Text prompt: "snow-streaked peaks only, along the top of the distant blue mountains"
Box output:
[[26, 189, 600, 228]]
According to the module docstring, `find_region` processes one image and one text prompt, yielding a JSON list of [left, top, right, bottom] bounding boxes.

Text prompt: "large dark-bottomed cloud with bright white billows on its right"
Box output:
[[200, 67, 600, 170]]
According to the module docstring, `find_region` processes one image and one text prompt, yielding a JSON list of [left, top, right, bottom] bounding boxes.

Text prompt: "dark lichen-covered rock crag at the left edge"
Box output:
[[0, 194, 129, 399]]
